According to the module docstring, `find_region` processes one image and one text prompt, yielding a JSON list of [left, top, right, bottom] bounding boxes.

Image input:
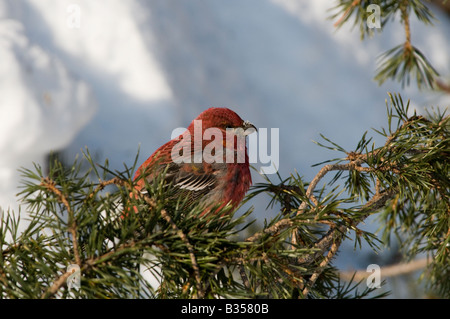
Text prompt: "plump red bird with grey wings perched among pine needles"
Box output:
[[134, 108, 256, 215]]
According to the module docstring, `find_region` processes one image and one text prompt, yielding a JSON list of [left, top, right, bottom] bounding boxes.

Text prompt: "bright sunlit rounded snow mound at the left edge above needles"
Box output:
[[0, 4, 95, 218]]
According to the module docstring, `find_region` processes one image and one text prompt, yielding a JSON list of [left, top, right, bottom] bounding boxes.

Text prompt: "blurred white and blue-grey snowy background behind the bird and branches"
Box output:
[[0, 0, 450, 298]]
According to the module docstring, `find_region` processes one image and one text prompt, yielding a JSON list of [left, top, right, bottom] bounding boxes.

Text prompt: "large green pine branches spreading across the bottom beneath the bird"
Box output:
[[0, 95, 450, 298]]
